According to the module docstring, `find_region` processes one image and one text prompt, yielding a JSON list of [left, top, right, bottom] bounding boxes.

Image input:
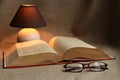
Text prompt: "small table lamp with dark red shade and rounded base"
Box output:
[[10, 4, 47, 42]]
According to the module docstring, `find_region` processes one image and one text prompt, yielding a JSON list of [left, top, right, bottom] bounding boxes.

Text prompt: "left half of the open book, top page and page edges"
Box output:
[[5, 40, 61, 66]]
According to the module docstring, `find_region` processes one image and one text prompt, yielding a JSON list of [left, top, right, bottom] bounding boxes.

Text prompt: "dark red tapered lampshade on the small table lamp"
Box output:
[[10, 4, 47, 28]]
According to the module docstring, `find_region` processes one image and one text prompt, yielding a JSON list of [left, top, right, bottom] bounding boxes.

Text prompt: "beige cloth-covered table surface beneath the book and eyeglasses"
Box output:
[[0, 45, 120, 80]]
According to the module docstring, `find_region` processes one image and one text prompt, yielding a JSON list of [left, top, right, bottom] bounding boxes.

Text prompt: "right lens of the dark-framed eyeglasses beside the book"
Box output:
[[89, 62, 107, 72]]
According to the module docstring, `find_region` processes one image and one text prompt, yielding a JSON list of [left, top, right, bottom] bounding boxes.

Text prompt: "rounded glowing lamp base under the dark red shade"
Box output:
[[17, 28, 40, 42]]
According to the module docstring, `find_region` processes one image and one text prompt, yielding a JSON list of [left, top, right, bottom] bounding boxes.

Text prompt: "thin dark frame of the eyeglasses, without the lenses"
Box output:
[[63, 61, 108, 72]]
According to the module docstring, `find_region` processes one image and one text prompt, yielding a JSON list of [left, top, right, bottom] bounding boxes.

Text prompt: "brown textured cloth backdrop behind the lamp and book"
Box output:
[[0, 0, 120, 43]]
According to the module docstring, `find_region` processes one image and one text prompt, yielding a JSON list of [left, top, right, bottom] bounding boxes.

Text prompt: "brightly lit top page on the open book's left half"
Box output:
[[16, 40, 57, 56]]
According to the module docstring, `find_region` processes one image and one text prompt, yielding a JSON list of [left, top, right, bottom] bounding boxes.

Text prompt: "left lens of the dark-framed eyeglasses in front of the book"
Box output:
[[65, 63, 83, 72]]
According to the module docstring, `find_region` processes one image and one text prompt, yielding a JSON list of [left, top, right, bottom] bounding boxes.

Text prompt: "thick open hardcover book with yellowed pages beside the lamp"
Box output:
[[3, 36, 113, 67]]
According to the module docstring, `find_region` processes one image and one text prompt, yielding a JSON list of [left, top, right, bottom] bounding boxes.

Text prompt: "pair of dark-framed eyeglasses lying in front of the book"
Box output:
[[63, 62, 108, 72]]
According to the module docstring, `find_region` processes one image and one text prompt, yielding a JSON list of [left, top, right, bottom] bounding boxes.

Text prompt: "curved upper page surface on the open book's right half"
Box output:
[[49, 36, 96, 53]]
